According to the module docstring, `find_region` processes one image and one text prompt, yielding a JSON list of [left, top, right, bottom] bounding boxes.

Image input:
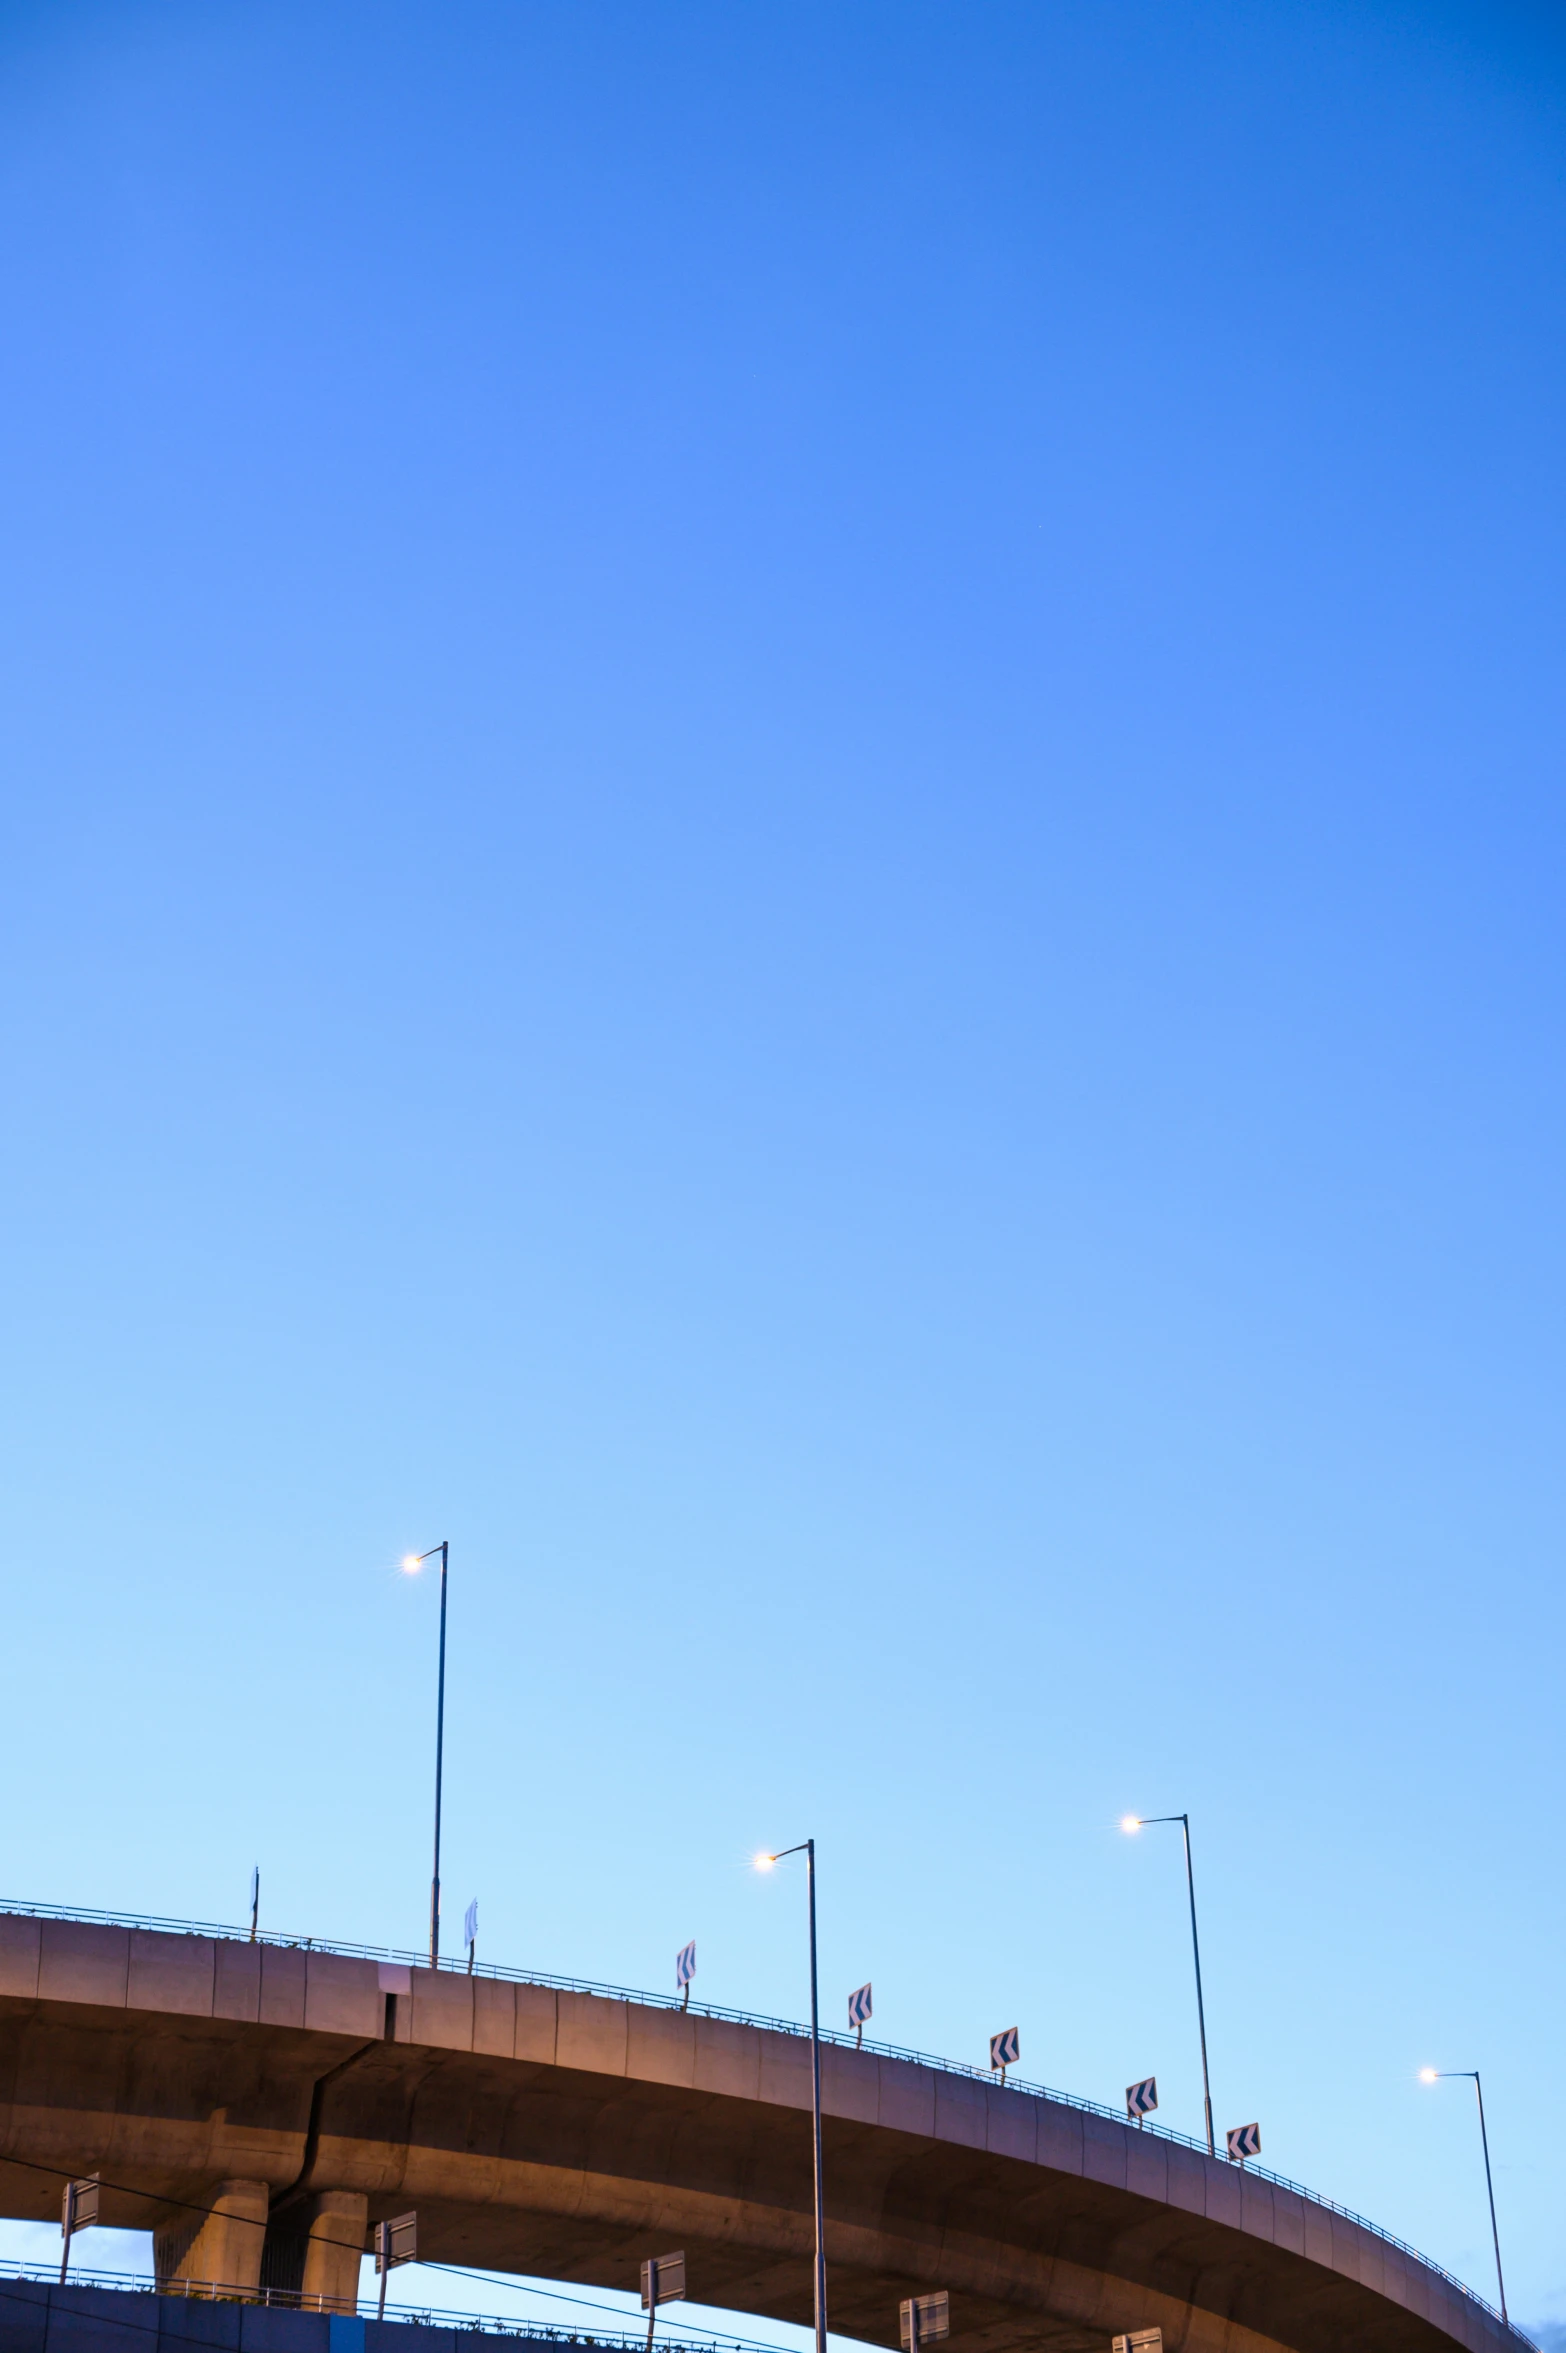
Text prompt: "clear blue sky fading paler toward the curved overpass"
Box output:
[[0, 0, 1566, 2329]]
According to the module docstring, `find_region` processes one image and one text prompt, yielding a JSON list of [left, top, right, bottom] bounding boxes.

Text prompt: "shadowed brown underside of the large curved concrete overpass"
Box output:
[[0, 2000, 1451, 2353]]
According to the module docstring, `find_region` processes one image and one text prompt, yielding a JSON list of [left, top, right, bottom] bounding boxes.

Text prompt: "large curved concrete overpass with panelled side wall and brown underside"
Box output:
[[0, 1911, 1526, 2353]]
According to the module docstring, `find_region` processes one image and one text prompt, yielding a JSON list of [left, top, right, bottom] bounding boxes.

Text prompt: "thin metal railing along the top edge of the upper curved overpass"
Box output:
[[0, 1897, 1538, 2353]]
